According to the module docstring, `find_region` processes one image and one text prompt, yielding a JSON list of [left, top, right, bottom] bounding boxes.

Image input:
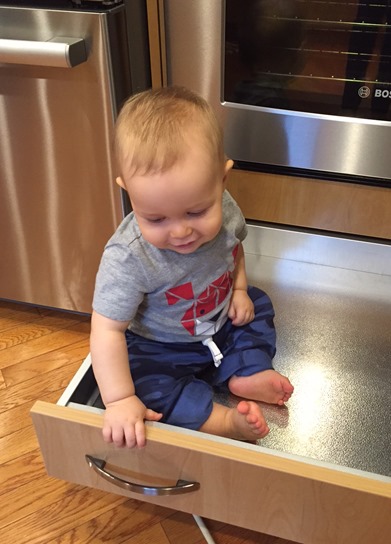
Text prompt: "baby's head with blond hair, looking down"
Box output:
[[116, 87, 233, 254]]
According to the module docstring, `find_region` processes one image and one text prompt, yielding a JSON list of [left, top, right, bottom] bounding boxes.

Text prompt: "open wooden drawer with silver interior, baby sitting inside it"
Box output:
[[32, 226, 391, 544]]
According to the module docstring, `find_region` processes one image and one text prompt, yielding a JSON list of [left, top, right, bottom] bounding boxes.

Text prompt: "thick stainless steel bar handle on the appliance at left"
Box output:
[[0, 37, 87, 68]]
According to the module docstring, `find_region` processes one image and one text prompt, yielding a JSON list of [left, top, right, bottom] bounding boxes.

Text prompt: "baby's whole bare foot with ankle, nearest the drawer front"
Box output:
[[199, 400, 269, 440]]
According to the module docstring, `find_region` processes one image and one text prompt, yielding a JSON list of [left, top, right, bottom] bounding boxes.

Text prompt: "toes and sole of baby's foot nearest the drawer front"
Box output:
[[229, 400, 269, 440]]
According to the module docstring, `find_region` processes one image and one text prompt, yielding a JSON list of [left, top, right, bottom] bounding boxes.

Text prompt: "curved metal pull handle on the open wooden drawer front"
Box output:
[[85, 455, 200, 495]]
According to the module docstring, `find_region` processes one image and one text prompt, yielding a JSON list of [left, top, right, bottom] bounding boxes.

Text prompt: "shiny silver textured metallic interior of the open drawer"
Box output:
[[218, 225, 391, 476]]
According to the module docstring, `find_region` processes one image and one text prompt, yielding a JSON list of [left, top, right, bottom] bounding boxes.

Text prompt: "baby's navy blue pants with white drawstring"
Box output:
[[126, 287, 276, 429]]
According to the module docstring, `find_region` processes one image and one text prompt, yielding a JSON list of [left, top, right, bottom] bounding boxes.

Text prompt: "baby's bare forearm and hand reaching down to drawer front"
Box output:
[[91, 312, 162, 447]]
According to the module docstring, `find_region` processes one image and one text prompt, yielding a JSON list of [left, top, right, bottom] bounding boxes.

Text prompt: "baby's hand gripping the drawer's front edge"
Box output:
[[102, 395, 163, 448]]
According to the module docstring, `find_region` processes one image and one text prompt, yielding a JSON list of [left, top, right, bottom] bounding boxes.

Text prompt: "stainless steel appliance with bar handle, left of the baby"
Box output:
[[0, 0, 150, 312]]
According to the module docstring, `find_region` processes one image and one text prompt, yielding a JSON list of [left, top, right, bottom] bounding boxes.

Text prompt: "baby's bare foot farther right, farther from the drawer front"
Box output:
[[228, 369, 294, 406]]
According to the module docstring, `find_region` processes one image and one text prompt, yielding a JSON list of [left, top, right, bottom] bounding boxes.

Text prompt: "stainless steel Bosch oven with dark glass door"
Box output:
[[164, 0, 391, 185]]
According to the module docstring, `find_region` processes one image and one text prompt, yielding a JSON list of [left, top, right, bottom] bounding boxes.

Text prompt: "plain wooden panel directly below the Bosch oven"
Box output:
[[228, 170, 391, 240]]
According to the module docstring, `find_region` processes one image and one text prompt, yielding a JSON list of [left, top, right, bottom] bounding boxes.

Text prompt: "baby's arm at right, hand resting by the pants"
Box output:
[[228, 244, 254, 326]]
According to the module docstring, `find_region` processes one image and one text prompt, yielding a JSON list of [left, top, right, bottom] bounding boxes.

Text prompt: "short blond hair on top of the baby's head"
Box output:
[[114, 86, 224, 177]]
